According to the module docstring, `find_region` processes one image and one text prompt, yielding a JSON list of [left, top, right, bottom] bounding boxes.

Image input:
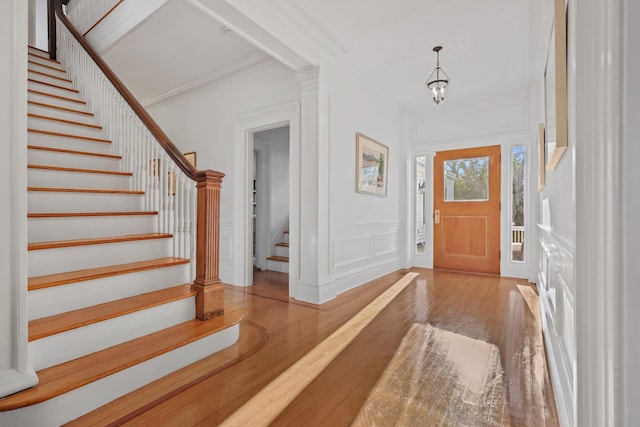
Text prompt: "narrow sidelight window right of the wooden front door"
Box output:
[[511, 145, 526, 261]]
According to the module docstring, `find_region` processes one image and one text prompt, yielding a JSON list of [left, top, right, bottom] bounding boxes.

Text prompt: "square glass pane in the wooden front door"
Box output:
[[443, 157, 489, 202]]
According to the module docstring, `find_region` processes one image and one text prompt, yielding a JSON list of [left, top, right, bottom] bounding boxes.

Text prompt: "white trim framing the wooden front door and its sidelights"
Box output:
[[407, 132, 538, 279]]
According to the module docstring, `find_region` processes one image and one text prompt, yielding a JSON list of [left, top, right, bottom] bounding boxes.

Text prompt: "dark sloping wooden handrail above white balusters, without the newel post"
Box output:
[[49, 0, 199, 181]]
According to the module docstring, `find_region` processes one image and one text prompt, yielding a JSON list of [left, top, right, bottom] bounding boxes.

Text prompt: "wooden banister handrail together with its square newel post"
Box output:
[[49, 0, 224, 320]]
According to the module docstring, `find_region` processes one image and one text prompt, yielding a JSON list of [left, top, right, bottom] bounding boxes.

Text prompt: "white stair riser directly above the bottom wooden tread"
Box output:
[[29, 297, 196, 371]]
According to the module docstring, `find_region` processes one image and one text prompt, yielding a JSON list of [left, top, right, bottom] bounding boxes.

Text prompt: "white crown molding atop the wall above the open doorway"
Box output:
[[142, 52, 273, 108]]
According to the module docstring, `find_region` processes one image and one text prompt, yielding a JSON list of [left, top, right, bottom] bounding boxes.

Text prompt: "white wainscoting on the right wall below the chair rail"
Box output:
[[538, 227, 576, 425]]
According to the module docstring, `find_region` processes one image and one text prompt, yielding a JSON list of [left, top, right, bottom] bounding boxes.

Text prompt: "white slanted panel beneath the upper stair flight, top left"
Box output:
[[87, 0, 168, 54]]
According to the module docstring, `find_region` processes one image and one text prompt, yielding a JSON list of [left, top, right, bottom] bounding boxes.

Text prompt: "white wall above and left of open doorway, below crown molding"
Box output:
[[149, 61, 299, 284]]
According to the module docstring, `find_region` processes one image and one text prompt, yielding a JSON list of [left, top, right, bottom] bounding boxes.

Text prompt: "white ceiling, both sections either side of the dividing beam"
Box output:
[[105, 0, 536, 111]]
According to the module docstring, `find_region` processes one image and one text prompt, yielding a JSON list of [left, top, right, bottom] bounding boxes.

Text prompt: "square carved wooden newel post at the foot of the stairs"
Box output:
[[192, 170, 224, 320]]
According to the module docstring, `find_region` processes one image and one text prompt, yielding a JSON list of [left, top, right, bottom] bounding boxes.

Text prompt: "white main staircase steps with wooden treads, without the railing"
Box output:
[[0, 48, 241, 427]]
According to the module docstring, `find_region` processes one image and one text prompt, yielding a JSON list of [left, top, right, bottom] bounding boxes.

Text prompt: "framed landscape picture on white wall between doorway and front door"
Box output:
[[356, 132, 389, 197]]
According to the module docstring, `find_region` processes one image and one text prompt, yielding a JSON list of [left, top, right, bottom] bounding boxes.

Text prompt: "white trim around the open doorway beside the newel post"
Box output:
[[232, 102, 300, 298]]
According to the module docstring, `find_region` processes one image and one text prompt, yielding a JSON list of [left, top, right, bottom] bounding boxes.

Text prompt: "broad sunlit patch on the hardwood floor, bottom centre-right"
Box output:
[[353, 323, 509, 426]]
